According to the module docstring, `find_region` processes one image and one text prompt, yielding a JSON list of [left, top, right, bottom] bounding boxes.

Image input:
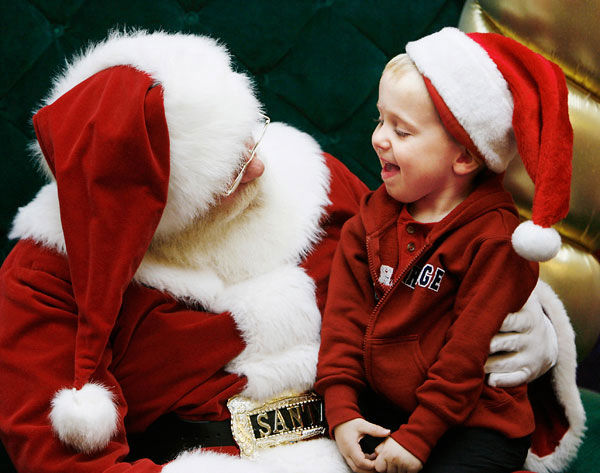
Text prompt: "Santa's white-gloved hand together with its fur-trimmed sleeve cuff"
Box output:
[[485, 280, 586, 472]]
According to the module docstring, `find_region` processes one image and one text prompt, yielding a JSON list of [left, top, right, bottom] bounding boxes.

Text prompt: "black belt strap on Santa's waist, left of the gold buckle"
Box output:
[[127, 413, 237, 464]]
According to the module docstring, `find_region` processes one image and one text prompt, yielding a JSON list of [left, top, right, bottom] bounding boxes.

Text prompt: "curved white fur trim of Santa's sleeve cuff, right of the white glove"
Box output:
[[525, 281, 585, 473]]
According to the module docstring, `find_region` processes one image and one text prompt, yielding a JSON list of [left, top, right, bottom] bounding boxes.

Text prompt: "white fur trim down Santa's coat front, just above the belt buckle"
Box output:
[[210, 265, 321, 400]]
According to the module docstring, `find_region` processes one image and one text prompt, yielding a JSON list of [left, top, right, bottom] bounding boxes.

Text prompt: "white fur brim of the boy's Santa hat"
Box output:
[[406, 28, 517, 172]]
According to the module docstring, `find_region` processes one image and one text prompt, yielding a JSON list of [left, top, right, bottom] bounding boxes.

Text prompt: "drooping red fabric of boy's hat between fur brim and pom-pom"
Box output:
[[468, 33, 573, 227]]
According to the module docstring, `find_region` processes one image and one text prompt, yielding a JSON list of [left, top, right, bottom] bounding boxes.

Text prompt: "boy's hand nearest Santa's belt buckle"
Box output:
[[333, 419, 390, 473]]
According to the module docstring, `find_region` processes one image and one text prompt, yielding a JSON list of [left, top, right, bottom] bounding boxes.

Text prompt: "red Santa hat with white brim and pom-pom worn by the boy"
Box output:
[[406, 28, 573, 261]]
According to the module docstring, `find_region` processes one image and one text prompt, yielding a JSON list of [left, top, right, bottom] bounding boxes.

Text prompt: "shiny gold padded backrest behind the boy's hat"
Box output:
[[459, 0, 600, 360]]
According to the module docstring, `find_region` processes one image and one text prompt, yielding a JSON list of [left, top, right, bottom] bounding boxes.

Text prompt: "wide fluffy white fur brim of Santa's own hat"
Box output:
[[36, 31, 261, 234]]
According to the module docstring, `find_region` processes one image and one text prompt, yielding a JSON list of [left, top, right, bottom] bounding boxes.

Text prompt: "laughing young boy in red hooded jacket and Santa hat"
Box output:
[[316, 28, 572, 473]]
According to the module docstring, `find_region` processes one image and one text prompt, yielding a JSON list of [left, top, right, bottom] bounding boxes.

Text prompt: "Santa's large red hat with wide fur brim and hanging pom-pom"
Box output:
[[33, 32, 261, 453]]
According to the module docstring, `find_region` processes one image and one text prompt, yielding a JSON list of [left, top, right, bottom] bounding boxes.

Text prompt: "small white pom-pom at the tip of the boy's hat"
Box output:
[[512, 220, 560, 261]]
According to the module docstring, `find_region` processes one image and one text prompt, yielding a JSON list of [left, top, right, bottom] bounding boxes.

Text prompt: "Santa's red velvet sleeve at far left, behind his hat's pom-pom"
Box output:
[[0, 242, 161, 473]]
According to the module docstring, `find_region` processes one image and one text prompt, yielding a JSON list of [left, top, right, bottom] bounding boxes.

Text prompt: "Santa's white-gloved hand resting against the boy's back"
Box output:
[[485, 291, 558, 387]]
